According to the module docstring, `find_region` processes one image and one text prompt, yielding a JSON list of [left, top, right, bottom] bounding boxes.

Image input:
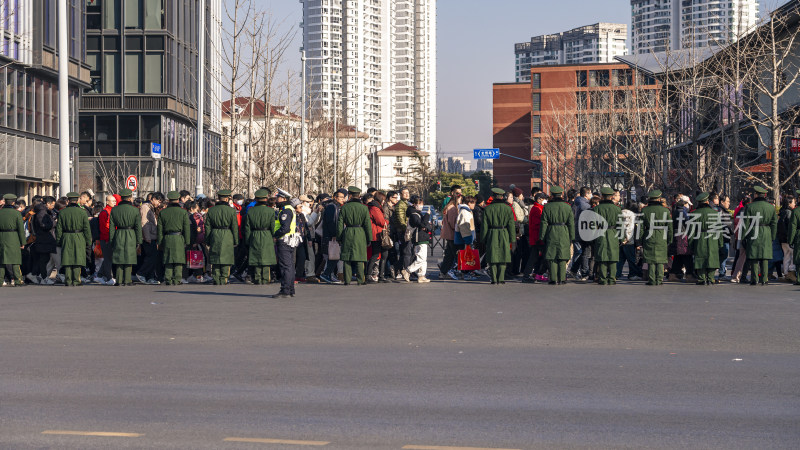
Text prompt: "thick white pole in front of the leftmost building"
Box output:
[[58, 0, 72, 193]]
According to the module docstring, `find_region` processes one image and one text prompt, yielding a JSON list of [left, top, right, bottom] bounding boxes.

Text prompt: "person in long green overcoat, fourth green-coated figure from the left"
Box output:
[[156, 191, 192, 286]]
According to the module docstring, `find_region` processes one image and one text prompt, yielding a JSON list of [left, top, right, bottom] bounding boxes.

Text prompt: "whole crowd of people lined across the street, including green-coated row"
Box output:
[[0, 186, 800, 298]]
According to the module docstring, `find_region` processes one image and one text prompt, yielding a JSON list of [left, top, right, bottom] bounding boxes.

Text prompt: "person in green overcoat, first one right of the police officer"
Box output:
[[337, 186, 372, 286]]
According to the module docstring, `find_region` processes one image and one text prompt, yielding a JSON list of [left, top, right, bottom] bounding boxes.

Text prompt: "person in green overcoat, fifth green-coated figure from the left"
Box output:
[[206, 189, 239, 285]]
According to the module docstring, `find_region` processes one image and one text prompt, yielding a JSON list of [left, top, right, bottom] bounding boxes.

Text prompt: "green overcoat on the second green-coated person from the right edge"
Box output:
[[741, 197, 778, 260]]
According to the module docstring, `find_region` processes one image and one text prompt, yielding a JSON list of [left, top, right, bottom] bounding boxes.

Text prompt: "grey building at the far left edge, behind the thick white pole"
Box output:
[[0, 0, 89, 197]]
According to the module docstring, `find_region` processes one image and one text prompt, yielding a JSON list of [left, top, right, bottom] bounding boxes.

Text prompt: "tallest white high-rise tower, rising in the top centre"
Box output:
[[300, 0, 436, 184]]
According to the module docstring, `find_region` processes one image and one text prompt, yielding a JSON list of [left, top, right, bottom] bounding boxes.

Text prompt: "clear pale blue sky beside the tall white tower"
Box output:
[[260, 0, 630, 157]]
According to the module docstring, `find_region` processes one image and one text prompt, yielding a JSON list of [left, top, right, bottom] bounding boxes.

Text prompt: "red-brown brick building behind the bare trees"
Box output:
[[493, 64, 659, 191]]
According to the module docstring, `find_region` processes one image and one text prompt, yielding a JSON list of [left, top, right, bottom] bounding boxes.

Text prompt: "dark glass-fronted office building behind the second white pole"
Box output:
[[77, 0, 222, 193]]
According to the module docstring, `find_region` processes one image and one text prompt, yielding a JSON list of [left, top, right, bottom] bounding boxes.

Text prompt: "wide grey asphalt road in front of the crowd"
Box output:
[[0, 281, 800, 449]]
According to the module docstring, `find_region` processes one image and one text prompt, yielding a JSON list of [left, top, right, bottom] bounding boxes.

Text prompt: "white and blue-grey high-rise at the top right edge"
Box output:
[[631, 0, 758, 54]]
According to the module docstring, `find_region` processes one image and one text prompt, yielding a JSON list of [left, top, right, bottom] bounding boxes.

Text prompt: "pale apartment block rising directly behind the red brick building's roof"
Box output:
[[514, 22, 628, 83]]
